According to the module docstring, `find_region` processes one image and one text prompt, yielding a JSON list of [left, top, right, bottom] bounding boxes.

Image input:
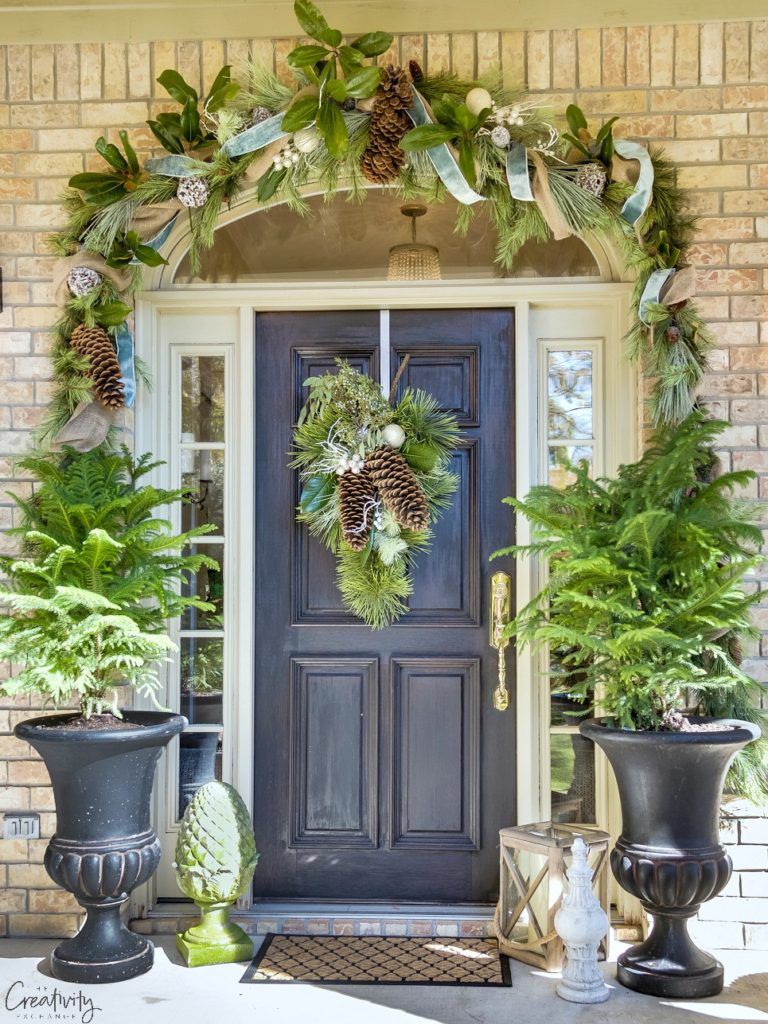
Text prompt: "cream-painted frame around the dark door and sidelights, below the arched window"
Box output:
[[131, 279, 640, 916]]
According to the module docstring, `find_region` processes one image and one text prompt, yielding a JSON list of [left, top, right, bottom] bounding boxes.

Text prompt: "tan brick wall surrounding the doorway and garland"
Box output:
[[0, 20, 768, 948]]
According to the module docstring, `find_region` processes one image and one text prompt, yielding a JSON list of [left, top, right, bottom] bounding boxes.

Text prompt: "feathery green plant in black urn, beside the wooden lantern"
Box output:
[[504, 413, 766, 998]]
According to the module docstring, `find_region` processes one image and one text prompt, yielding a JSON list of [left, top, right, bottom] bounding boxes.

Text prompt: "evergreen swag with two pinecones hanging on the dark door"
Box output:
[[292, 355, 460, 630]]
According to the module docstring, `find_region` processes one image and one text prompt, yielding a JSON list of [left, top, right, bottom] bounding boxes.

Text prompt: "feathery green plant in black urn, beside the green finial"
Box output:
[[0, 449, 215, 983]]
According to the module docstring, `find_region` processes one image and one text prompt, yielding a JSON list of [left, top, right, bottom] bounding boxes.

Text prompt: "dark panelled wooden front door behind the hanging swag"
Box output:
[[254, 309, 515, 903]]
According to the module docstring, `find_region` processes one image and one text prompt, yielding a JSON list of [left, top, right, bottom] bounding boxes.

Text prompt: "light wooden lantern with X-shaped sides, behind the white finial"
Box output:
[[494, 821, 610, 971]]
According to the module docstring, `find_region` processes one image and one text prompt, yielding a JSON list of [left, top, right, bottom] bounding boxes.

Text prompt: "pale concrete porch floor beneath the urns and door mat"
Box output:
[[0, 936, 768, 1024]]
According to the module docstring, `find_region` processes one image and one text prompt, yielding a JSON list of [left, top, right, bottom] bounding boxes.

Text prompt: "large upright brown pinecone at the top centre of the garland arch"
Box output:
[[360, 65, 414, 185]]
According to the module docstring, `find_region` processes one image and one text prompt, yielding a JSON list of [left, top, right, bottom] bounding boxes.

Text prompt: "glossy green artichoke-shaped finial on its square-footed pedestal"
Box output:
[[174, 782, 259, 967]]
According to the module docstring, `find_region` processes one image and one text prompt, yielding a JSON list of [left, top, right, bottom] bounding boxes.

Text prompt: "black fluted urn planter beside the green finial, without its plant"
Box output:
[[15, 712, 186, 984]]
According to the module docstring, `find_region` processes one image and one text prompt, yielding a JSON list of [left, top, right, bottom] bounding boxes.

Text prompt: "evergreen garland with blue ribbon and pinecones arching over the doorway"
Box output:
[[45, 0, 711, 450]]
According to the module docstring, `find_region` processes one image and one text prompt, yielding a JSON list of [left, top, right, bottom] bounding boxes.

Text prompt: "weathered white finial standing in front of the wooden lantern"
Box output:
[[555, 836, 610, 1002]]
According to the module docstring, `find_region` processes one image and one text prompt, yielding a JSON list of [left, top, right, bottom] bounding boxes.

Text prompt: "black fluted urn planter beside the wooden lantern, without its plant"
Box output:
[[580, 719, 760, 999]]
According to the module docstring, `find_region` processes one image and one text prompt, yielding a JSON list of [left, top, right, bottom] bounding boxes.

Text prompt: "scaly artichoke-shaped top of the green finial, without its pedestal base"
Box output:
[[174, 782, 259, 904]]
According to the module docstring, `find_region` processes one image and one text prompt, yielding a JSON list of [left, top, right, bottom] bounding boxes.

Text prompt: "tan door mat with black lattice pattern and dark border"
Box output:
[[241, 934, 512, 987]]
